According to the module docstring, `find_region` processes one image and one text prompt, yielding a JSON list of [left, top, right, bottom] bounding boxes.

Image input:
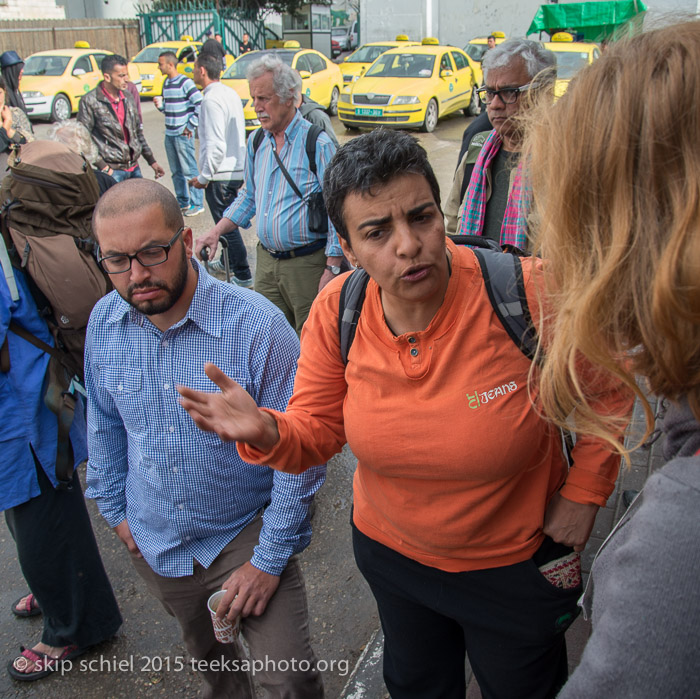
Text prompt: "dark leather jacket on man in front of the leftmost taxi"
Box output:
[[78, 82, 156, 170]]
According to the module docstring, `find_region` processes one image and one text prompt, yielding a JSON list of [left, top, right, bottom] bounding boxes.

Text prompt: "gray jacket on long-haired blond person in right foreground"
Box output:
[[559, 401, 700, 699]]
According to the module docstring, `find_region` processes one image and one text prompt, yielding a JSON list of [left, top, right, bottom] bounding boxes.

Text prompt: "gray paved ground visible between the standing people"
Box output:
[[0, 102, 469, 699]]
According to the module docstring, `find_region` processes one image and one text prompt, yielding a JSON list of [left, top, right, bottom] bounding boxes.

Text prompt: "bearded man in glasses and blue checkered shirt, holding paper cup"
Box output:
[[85, 180, 325, 699]]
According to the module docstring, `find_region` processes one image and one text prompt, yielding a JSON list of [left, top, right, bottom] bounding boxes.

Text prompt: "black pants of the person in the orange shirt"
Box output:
[[353, 526, 581, 699]]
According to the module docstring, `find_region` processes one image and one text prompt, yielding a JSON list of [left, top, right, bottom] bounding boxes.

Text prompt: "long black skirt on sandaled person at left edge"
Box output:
[[5, 456, 122, 648]]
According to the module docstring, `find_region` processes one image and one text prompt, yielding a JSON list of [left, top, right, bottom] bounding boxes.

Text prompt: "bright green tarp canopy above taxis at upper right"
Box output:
[[527, 0, 647, 41]]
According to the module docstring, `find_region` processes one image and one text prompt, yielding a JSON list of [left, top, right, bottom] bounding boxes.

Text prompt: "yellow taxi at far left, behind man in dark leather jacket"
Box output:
[[19, 41, 141, 121]]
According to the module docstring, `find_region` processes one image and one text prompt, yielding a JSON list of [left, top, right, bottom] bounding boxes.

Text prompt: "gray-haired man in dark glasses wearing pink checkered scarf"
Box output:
[[445, 39, 556, 250]]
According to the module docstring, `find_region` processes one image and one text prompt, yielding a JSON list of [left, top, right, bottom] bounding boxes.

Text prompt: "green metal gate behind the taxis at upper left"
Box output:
[[137, 0, 265, 56]]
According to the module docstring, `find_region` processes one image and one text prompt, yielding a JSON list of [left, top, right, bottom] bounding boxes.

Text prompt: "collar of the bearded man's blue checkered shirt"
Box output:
[[105, 258, 223, 338]]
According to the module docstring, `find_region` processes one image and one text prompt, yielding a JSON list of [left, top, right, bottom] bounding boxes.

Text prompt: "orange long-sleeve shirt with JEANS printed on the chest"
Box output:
[[238, 242, 629, 572]]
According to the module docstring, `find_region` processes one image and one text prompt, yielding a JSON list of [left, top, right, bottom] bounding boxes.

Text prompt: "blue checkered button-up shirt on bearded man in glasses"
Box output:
[[85, 262, 325, 577]]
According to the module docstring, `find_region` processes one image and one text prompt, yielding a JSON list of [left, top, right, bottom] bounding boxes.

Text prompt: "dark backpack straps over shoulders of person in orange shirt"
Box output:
[[338, 235, 537, 364]]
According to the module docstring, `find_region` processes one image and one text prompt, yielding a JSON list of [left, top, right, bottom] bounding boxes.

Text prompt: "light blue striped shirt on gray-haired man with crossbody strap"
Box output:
[[224, 110, 343, 257]]
